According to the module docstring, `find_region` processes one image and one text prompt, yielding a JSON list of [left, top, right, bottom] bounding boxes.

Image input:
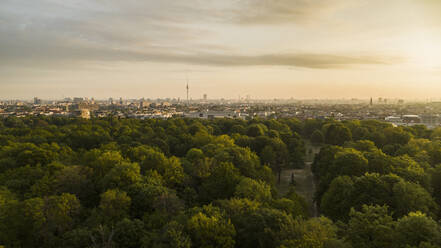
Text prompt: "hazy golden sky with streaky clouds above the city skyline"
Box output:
[[0, 0, 441, 99]]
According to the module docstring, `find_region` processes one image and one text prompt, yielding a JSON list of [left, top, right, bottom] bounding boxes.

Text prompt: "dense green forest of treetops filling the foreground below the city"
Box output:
[[0, 117, 441, 248]]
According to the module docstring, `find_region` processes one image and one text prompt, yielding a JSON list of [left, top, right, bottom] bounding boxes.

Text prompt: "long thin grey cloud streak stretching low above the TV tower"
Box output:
[[0, 34, 402, 69]]
